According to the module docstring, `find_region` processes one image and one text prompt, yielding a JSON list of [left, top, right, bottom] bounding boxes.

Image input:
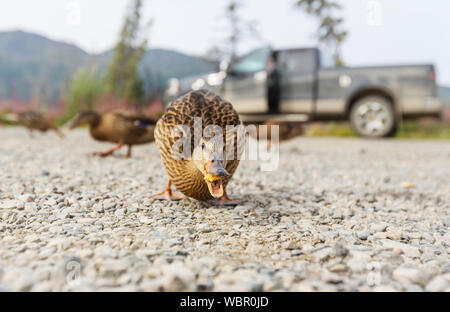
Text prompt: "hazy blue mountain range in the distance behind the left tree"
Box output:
[[0, 30, 216, 102]]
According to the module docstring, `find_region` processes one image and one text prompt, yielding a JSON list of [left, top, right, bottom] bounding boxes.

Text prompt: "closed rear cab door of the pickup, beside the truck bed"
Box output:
[[278, 49, 318, 113]]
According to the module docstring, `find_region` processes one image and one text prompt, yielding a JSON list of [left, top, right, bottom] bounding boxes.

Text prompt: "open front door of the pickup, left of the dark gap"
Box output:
[[223, 47, 271, 113]]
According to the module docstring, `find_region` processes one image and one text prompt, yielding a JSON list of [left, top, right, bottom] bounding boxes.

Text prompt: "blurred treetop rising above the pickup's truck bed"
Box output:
[[297, 0, 347, 66]]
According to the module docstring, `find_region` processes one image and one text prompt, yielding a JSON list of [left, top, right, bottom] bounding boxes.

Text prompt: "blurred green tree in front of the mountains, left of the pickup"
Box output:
[[105, 0, 147, 105]]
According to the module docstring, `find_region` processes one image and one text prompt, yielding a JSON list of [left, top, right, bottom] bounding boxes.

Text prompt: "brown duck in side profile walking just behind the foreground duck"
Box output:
[[67, 111, 156, 157]]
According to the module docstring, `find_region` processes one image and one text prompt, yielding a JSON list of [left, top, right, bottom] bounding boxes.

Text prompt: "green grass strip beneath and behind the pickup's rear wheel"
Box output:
[[307, 120, 450, 139]]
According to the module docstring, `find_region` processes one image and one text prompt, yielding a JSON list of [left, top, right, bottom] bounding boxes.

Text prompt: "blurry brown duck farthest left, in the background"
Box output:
[[4, 111, 64, 137]]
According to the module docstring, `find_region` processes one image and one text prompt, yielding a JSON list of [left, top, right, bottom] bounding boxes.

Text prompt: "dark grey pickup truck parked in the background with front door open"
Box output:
[[166, 47, 442, 137]]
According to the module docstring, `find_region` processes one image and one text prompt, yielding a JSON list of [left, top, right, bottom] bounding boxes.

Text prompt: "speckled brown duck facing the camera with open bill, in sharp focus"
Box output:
[[151, 90, 241, 205]]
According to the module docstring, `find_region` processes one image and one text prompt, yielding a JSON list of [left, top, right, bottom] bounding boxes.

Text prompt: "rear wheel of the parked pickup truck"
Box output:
[[350, 96, 396, 138]]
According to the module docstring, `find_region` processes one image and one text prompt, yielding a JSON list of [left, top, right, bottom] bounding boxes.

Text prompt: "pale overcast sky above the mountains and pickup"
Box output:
[[0, 0, 450, 85]]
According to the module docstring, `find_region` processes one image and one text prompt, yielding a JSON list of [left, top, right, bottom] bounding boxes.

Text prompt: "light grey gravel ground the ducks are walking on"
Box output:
[[0, 128, 450, 291]]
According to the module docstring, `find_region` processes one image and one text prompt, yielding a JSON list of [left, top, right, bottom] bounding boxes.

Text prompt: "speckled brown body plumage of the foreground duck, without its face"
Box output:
[[155, 90, 240, 200]]
